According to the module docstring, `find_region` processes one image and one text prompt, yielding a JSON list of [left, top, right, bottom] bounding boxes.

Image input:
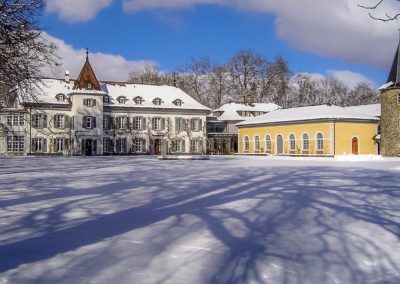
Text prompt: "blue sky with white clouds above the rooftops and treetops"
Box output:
[[40, 0, 398, 87]]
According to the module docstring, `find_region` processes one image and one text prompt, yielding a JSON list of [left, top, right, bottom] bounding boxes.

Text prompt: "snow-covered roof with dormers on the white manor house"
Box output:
[[23, 79, 210, 110]]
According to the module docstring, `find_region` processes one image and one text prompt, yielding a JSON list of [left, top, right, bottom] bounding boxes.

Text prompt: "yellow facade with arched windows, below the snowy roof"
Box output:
[[238, 121, 377, 156]]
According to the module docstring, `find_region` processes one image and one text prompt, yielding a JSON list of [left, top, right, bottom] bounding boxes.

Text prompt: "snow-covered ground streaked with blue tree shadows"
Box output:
[[0, 157, 400, 284]]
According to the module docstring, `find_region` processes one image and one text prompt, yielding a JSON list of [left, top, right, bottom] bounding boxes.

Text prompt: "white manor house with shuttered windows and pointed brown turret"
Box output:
[[0, 55, 210, 156]]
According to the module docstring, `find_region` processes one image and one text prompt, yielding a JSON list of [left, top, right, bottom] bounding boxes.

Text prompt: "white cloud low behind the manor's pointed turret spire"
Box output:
[[44, 33, 155, 81]]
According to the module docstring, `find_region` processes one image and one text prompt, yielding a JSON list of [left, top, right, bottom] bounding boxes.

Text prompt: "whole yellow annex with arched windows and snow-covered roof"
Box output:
[[237, 105, 379, 156]]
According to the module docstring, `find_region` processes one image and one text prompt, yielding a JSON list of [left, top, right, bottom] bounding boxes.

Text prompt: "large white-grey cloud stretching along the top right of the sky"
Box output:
[[123, 0, 399, 68]]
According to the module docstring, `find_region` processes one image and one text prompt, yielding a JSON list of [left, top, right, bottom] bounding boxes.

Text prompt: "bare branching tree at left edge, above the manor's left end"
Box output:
[[0, 0, 56, 106]]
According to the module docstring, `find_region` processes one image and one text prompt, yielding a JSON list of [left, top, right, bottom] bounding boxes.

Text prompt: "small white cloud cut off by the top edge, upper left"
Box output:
[[46, 0, 113, 22]]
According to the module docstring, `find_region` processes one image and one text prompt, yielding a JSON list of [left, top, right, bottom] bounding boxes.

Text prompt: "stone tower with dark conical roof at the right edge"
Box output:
[[380, 38, 400, 157]]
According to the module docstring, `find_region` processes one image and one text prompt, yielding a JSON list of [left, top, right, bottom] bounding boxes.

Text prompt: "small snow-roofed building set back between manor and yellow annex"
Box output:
[[207, 103, 279, 154]]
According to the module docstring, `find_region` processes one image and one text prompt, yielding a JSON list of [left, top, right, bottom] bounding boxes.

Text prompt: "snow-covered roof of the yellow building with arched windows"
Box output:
[[236, 105, 379, 126]]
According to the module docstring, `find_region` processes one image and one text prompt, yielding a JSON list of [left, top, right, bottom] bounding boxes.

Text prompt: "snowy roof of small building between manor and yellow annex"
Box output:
[[213, 103, 279, 121]]
